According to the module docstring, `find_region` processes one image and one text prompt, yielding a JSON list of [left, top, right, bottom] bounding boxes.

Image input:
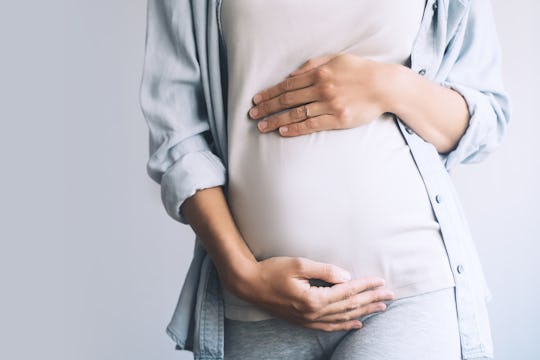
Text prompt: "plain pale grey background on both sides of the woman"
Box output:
[[0, 0, 540, 360]]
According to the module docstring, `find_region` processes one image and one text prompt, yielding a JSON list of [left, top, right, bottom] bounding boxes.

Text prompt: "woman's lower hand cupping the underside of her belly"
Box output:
[[224, 257, 394, 331]]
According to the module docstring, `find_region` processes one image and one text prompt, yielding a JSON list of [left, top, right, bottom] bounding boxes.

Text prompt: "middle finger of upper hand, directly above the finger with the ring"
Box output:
[[248, 82, 320, 119]]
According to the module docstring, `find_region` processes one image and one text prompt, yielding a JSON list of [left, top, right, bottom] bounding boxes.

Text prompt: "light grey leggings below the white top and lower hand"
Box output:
[[224, 287, 472, 360]]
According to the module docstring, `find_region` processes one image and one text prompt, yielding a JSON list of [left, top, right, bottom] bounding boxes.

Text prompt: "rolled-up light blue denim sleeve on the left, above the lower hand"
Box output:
[[139, 0, 226, 224]]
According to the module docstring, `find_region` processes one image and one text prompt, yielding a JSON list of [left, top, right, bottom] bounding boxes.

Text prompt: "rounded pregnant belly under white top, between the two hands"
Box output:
[[228, 116, 439, 276]]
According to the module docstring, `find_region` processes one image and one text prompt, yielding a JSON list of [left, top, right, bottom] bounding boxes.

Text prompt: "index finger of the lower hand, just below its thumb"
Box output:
[[308, 276, 386, 307]]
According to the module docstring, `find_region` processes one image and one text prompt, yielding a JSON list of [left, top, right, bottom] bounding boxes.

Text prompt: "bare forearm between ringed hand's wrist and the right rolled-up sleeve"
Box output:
[[385, 64, 470, 154]]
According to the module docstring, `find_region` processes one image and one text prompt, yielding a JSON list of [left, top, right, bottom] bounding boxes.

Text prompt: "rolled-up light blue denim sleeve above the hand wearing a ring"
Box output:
[[439, 0, 510, 170]]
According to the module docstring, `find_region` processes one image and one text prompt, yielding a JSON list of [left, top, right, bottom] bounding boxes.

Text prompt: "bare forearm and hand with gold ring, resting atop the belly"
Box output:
[[248, 53, 470, 154]]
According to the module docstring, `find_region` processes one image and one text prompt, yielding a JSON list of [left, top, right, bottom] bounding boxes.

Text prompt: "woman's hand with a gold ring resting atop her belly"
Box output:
[[249, 53, 392, 136]]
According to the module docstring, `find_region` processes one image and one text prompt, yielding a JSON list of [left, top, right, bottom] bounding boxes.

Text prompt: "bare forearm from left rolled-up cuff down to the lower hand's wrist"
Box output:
[[180, 186, 257, 296]]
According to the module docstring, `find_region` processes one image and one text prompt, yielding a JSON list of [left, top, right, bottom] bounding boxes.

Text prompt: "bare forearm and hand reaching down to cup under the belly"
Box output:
[[181, 186, 394, 331]]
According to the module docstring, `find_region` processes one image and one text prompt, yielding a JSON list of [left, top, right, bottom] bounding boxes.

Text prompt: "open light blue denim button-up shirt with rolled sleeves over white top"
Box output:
[[139, 0, 510, 359]]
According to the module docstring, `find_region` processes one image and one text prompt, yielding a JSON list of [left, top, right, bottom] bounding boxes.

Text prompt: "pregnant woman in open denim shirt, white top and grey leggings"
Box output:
[[141, 0, 509, 360]]
